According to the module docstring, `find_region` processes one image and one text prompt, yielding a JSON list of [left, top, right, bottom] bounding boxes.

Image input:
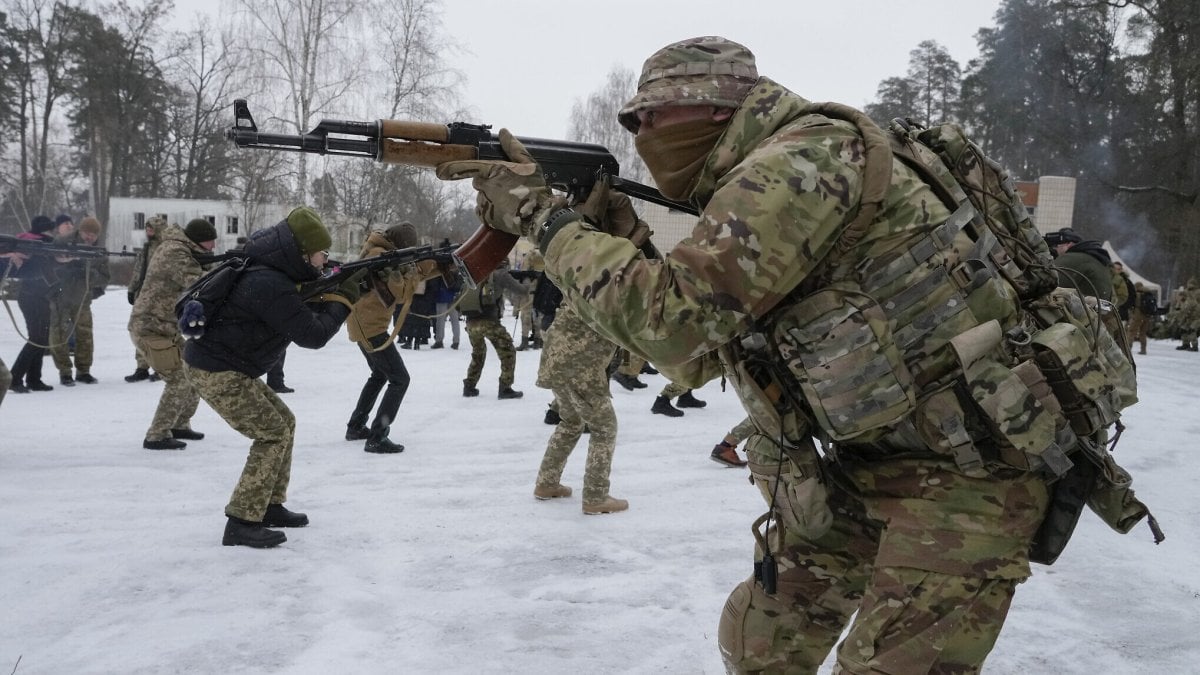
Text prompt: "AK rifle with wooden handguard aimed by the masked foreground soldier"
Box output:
[[226, 98, 697, 282]]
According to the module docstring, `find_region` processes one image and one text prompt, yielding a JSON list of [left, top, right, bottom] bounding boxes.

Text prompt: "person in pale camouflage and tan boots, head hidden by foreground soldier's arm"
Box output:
[[533, 299, 629, 515]]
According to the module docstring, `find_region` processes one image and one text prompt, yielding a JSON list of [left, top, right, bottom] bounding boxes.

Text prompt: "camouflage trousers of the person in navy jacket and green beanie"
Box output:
[[188, 368, 296, 522]]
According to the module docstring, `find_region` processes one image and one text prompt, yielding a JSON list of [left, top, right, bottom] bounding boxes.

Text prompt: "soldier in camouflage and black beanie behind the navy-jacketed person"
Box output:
[[128, 219, 217, 450]]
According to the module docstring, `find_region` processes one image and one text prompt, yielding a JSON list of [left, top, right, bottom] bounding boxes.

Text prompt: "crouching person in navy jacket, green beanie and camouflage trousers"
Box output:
[[181, 207, 358, 548]]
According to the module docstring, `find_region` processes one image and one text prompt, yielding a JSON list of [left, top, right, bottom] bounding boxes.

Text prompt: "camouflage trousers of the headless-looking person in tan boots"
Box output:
[[538, 371, 617, 503]]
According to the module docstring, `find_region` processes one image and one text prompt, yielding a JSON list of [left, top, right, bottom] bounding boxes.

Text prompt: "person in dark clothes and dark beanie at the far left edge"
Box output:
[[8, 216, 65, 394]]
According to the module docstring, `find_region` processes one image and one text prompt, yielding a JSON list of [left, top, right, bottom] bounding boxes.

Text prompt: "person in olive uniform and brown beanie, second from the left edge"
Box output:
[[50, 216, 109, 387]]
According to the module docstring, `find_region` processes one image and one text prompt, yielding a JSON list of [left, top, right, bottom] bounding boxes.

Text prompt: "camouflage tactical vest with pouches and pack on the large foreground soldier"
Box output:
[[730, 103, 1136, 478]]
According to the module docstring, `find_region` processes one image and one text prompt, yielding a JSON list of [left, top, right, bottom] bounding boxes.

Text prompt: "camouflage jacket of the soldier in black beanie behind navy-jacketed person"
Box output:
[[130, 225, 208, 338]]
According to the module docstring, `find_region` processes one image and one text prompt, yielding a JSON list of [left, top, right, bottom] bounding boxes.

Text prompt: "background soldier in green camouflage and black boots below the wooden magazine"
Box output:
[[458, 265, 526, 399]]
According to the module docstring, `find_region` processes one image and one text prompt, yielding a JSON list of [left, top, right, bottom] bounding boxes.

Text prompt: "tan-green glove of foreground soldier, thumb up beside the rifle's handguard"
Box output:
[[437, 129, 564, 239]]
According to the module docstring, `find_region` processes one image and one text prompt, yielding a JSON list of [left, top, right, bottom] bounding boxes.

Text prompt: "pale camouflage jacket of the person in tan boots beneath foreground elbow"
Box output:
[[538, 300, 617, 389]]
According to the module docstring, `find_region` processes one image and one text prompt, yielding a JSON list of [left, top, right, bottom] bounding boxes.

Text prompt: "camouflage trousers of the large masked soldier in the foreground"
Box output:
[[719, 458, 1048, 675]]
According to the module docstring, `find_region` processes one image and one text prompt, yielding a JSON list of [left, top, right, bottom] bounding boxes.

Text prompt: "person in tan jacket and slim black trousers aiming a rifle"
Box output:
[[346, 222, 437, 453]]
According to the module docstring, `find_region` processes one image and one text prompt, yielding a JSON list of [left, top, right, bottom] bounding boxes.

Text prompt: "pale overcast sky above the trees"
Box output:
[[175, 0, 1000, 138]]
